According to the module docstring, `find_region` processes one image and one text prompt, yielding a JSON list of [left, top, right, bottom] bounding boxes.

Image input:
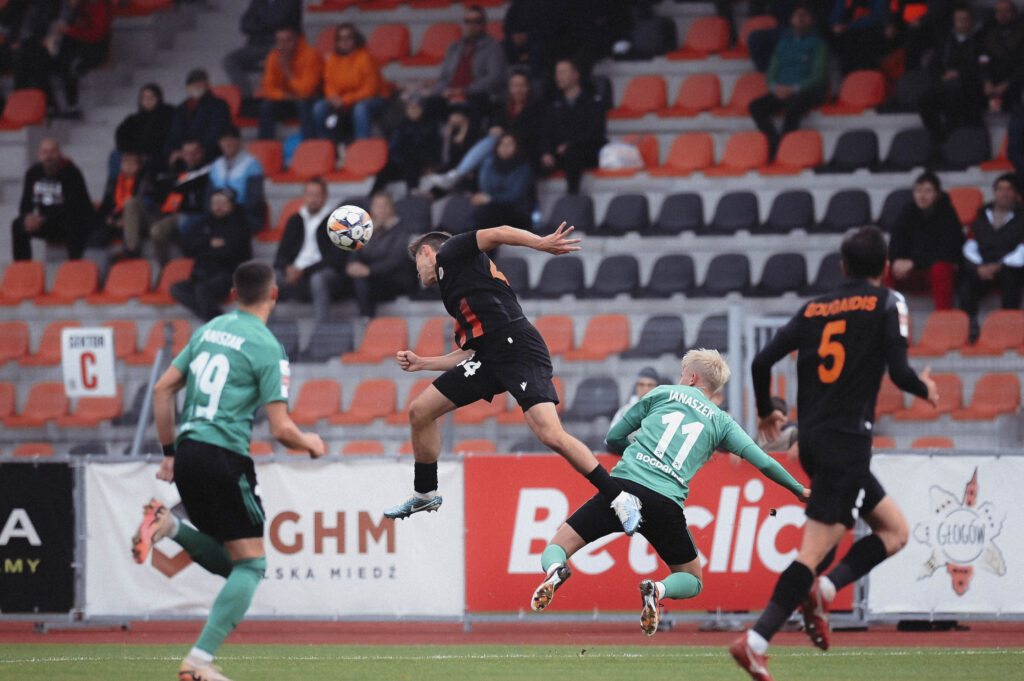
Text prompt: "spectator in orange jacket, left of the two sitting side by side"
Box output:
[[259, 28, 324, 139]]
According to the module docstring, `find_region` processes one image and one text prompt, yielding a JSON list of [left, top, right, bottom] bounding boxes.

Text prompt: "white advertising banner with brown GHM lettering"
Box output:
[[85, 458, 465, 618]]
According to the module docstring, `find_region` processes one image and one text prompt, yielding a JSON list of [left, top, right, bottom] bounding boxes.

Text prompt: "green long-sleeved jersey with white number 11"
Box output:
[[607, 385, 804, 506]]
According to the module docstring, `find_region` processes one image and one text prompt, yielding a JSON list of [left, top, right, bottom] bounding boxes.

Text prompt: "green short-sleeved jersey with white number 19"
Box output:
[[173, 310, 291, 456]]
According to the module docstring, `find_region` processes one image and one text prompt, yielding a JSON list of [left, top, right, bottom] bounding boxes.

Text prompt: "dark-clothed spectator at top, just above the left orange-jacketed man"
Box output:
[[224, 0, 302, 99]]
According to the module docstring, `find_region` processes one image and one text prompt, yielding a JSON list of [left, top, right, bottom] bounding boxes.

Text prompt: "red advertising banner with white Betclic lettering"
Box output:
[[466, 455, 851, 612]]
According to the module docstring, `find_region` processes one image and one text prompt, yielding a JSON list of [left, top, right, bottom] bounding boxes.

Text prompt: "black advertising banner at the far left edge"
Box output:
[[0, 463, 75, 613]]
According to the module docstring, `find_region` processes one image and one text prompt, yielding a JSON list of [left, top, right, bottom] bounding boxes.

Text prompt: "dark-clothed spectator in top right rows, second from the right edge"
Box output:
[[918, 5, 983, 148]]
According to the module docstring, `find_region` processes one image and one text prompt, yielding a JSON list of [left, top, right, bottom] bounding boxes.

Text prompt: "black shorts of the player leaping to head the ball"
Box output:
[[434, 320, 558, 412]]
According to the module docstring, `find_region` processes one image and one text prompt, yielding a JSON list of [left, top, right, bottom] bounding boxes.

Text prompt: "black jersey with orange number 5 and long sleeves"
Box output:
[[751, 280, 928, 434]]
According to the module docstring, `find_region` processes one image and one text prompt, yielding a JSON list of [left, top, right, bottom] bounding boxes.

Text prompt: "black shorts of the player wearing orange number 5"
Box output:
[[799, 431, 886, 527]]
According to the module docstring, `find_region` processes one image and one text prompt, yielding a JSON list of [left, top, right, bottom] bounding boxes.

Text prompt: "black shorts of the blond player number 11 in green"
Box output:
[[565, 477, 697, 565]]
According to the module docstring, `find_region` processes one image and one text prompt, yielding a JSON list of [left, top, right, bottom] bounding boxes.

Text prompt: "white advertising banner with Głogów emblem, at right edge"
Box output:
[[867, 455, 1024, 614]]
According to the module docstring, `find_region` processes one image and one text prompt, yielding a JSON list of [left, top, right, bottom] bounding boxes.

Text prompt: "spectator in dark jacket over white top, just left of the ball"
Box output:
[[273, 177, 346, 324]]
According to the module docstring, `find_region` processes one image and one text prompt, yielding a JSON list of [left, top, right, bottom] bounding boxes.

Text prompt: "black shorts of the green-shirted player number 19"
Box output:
[[174, 439, 265, 542]]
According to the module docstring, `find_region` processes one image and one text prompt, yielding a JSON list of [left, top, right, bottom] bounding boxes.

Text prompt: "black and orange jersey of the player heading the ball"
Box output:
[[435, 231, 525, 348]]
